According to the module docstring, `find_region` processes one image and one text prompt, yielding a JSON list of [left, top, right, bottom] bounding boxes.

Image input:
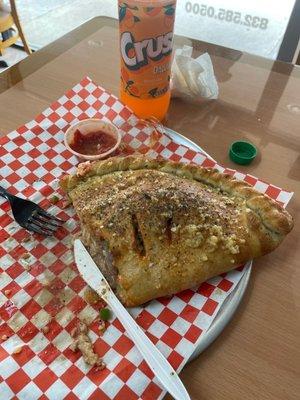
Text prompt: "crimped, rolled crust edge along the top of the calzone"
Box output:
[[61, 156, 293, 235]]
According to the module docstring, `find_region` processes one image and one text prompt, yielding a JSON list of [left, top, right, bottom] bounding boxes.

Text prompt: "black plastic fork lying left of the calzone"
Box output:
[[0, 186, 64, 236]]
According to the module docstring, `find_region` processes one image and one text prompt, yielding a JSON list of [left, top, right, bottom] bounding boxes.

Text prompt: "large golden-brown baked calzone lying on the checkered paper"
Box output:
[[61, 156, 293, 306]]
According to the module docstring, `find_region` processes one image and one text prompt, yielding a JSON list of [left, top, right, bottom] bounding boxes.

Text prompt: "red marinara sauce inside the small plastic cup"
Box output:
[[69, 129, 117, 156]]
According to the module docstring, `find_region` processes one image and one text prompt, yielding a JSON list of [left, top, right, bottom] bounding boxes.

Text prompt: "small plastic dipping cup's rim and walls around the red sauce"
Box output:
[[64, 118, 122, 160]]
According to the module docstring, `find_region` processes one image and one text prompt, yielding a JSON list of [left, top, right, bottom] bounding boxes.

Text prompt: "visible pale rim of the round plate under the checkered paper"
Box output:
[[165, 127, 252, 361]]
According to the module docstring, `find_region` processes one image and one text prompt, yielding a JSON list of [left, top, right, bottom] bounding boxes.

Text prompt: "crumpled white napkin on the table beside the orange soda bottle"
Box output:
[[171, 45, 219, 100]]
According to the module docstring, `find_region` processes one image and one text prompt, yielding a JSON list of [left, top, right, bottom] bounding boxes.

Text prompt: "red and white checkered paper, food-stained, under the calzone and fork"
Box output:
[[0, 78, 292, 400]]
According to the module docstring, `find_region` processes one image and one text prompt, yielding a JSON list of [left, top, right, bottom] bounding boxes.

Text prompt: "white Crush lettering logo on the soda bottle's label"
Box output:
[[121, 32, 173, 70]]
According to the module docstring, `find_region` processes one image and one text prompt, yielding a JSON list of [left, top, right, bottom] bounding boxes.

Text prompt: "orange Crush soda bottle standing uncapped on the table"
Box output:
[[118, 0, 176, 120]]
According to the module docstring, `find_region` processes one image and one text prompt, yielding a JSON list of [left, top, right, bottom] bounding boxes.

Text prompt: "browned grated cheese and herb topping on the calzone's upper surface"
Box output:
[[74, 170, 246, 261]]
